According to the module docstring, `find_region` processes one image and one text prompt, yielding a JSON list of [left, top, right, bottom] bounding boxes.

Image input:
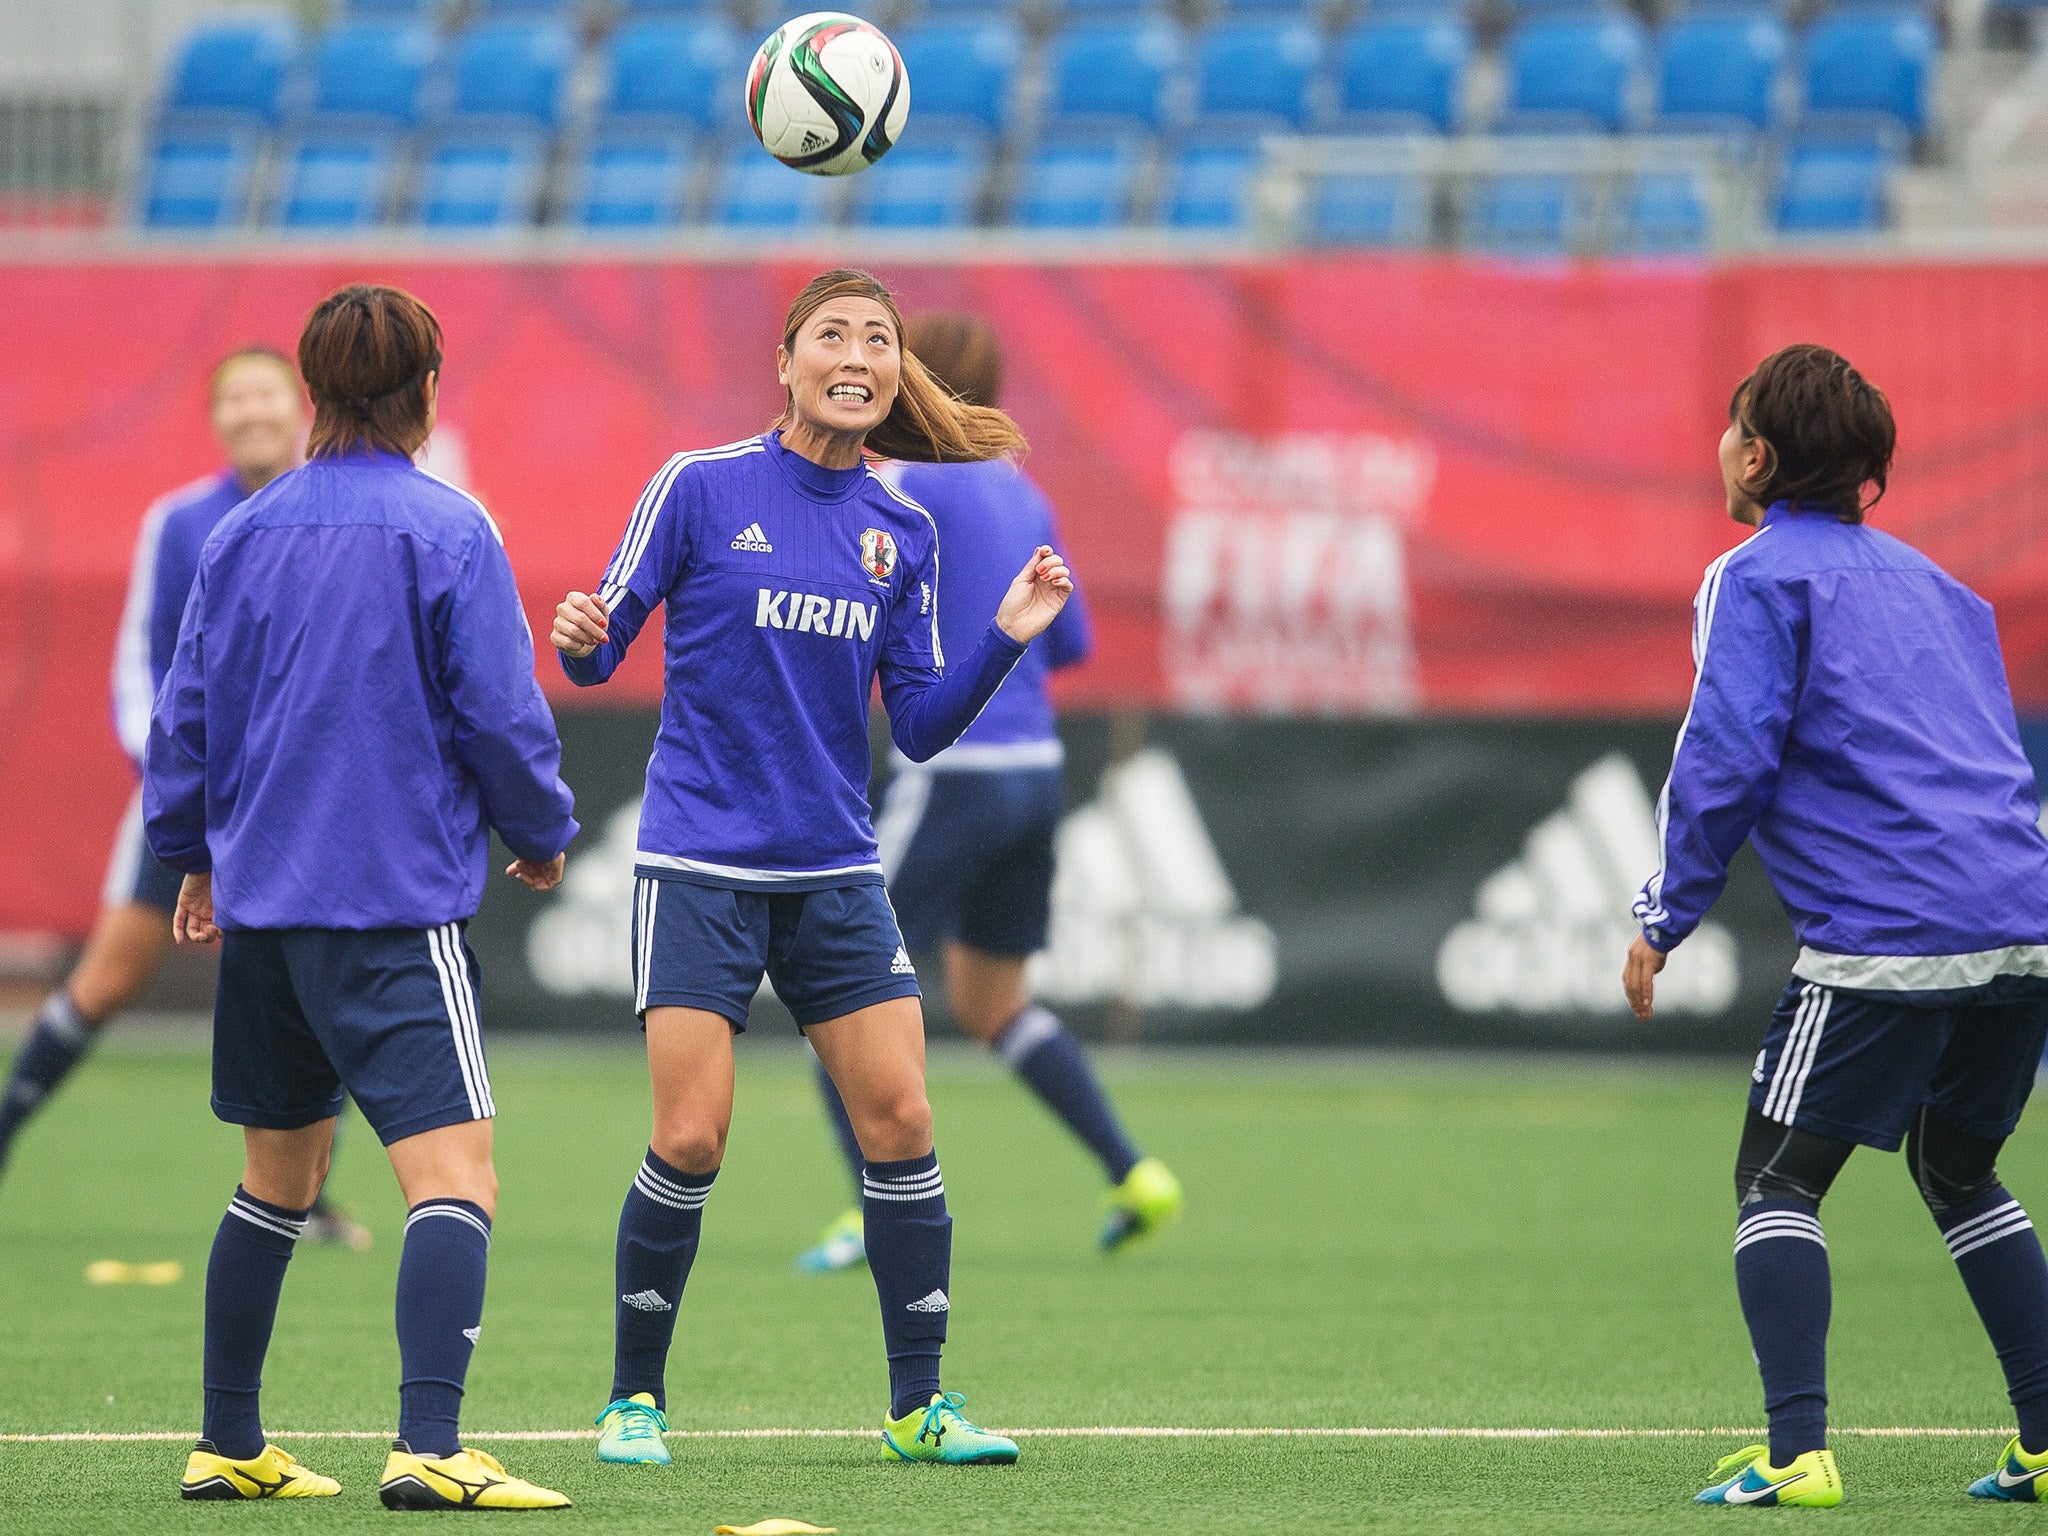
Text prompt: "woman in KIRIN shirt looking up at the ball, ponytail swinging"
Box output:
[[553, 270, 1073, 1462]]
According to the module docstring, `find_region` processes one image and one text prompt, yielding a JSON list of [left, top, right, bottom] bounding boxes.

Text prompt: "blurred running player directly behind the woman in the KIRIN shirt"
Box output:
[[797, 313, 1182, 1274]]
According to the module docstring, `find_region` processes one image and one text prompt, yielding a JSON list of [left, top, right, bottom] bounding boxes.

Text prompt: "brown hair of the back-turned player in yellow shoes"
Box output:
[[299, 283, 440, 459]]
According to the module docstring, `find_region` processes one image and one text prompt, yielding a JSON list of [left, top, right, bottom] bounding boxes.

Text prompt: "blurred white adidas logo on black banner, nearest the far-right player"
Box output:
[[1436, 752, 1741, 1014]]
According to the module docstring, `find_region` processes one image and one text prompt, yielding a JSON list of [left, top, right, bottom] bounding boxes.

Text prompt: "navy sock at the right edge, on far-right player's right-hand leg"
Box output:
[[1935, 1186, 2048, 1454]]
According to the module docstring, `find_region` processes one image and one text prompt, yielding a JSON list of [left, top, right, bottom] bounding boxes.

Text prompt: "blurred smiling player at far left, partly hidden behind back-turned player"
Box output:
[[0, 346, 369, 1247]]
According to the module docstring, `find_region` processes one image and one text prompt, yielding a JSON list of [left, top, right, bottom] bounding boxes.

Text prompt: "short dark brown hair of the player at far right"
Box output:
[[1729, 346, 1898, 522]]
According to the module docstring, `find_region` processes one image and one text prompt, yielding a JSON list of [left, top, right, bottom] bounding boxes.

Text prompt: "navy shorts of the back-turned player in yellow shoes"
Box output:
[[213, 924, 498, 1147]]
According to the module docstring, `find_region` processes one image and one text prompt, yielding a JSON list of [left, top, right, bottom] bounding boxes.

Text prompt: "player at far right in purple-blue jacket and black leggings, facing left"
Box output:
[[1624, 346, 2048, 1505]]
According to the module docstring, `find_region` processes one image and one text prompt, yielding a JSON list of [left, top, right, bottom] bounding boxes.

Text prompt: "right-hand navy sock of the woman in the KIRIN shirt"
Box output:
[[860, 1151, 952, 1419]]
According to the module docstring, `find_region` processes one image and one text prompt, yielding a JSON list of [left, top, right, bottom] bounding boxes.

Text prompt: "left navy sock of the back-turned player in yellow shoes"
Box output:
[[201, 1184, 305, 1462]]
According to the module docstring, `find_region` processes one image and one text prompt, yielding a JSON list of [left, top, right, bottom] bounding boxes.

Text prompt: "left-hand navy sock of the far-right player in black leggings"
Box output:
[[1735, 1200, 1833, 1466]]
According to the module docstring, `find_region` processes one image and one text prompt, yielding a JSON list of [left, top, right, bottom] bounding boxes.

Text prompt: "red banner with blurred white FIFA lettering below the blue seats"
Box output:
[[0, 254, 2048, 932]]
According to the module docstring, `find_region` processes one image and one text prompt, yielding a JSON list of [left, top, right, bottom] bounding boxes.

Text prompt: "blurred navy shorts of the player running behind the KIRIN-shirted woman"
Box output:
[[874, 768, 1063, 956]]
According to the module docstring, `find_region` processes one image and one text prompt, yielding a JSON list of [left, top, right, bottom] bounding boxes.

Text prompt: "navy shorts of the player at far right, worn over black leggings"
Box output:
[[1749, 977, 2048, 1151]]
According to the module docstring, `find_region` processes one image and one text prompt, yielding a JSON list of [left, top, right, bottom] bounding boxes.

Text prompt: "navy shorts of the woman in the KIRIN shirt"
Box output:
[[633, 874, 920, 1030]]
